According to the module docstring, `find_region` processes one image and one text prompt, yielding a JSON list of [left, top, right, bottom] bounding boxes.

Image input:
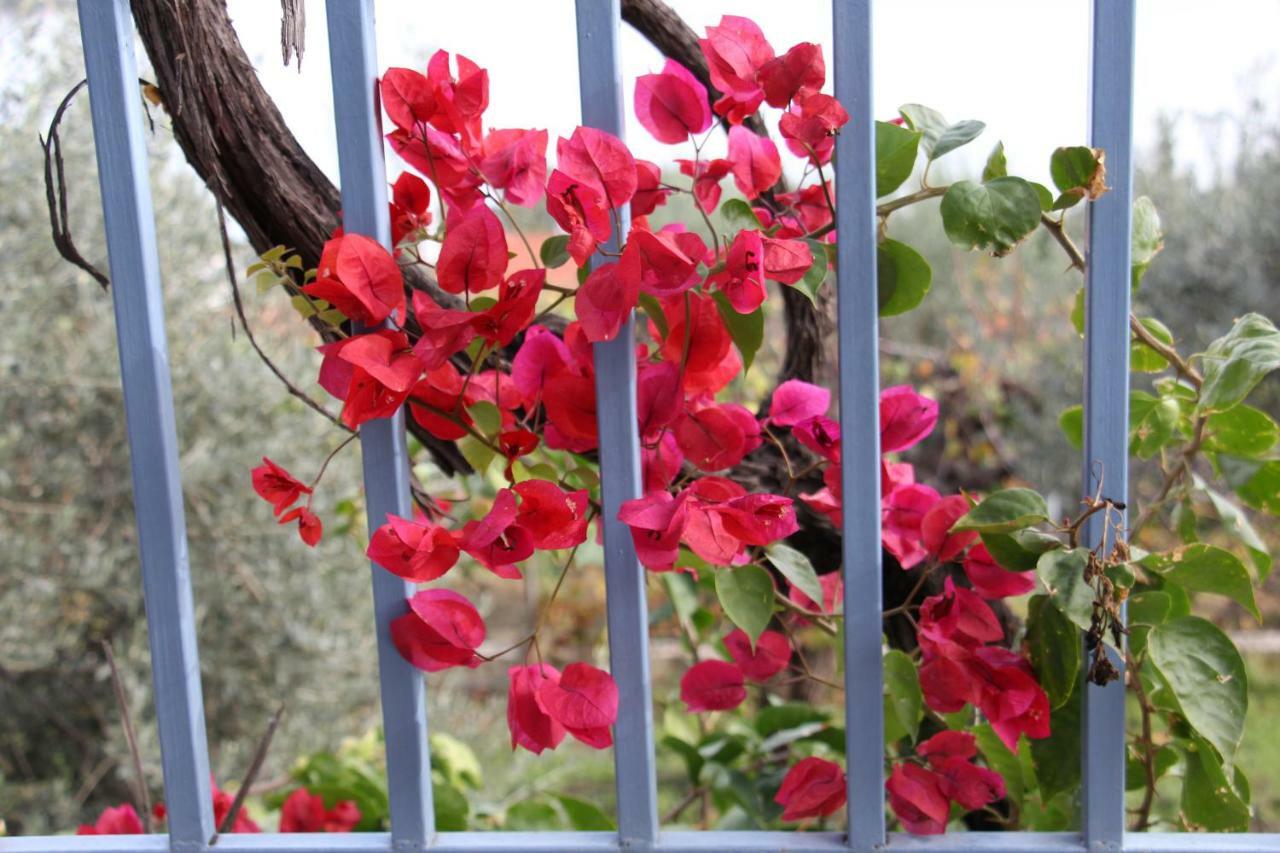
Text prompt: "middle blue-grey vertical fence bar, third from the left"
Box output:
[[576, 0, 658, 849]]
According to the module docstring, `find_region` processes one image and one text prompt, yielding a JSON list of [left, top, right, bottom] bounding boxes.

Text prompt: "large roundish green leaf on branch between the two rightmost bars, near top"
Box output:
[[940, 177, 1041, 255]]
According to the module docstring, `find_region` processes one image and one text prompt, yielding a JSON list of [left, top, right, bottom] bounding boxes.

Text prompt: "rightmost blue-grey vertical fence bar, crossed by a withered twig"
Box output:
[[1083, 0, 1134, 850]]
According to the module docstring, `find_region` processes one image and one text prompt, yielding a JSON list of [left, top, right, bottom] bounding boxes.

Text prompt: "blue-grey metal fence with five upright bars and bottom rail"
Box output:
[[10, 0, 1280, 853]]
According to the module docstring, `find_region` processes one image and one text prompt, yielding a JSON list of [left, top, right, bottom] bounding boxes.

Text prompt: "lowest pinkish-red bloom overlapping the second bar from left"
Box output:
[[392, 589, 485, 672]]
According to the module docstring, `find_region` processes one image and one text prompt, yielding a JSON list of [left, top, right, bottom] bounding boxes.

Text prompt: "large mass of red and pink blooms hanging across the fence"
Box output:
[[241, 15, 1047, 822]]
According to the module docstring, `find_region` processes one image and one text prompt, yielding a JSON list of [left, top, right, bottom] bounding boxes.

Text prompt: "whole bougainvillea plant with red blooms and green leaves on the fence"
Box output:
[[217, 15, 1280, 834]]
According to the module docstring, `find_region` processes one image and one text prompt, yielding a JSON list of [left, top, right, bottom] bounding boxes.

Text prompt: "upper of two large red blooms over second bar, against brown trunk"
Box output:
[[302, 234, 404, 325]]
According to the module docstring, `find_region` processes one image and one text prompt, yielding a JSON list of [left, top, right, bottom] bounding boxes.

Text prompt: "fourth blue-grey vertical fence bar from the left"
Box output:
[[832, 0, 884, 850]]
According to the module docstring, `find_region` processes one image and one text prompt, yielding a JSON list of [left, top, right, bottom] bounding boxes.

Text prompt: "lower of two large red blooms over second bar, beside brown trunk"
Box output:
[[319, 329, 422, 429]]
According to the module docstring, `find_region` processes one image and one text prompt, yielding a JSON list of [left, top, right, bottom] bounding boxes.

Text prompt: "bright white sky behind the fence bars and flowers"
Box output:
[[228, 0, 1280, 189]]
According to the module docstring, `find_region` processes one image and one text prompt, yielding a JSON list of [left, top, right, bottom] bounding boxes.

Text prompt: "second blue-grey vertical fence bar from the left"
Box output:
[[325, 0, 435, 849]]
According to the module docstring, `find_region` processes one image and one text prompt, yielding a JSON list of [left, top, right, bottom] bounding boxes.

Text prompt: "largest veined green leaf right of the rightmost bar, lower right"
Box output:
[[1147, 616, 1249, 762]]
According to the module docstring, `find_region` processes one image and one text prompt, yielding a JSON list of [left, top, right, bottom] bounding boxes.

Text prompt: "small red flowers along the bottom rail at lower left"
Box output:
[[76, 780, 360, 835]]
